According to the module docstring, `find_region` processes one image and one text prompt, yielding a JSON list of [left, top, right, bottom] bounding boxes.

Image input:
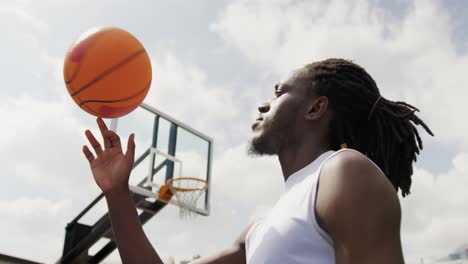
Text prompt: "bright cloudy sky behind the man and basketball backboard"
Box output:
[[0, 0, 468, 263]]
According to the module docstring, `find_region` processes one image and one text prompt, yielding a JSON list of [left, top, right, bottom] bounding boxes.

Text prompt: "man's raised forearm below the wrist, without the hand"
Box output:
[[105, 189, 163, 264]]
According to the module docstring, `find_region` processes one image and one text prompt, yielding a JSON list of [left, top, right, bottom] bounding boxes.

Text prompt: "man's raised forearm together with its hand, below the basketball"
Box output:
[[83, 118, 163, 264]]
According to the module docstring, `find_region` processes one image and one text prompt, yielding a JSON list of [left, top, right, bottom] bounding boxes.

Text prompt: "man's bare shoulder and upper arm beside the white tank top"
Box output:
[[315, 151, 403, 263]]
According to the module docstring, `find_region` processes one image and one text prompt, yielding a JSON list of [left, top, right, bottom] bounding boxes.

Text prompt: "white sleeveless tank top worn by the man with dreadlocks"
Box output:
[[245, 149, 358, 264]]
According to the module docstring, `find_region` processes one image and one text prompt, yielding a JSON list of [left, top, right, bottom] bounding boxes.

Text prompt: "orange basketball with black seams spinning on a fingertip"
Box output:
[[63, 27, 151, 118]]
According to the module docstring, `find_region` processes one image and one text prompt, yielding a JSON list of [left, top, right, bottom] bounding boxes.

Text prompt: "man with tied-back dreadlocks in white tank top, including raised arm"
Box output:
[[83, 59, 432, 264]]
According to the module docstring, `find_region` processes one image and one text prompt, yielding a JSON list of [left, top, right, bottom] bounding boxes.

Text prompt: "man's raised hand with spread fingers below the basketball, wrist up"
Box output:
[[83, 118, 135, 194]]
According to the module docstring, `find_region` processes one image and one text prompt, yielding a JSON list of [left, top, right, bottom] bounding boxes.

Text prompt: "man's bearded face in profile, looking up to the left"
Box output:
[[249, 74, 306, 155]]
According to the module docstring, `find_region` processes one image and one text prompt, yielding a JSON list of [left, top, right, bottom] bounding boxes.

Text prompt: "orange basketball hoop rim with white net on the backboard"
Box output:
[[160, 177, 208, 219]]
